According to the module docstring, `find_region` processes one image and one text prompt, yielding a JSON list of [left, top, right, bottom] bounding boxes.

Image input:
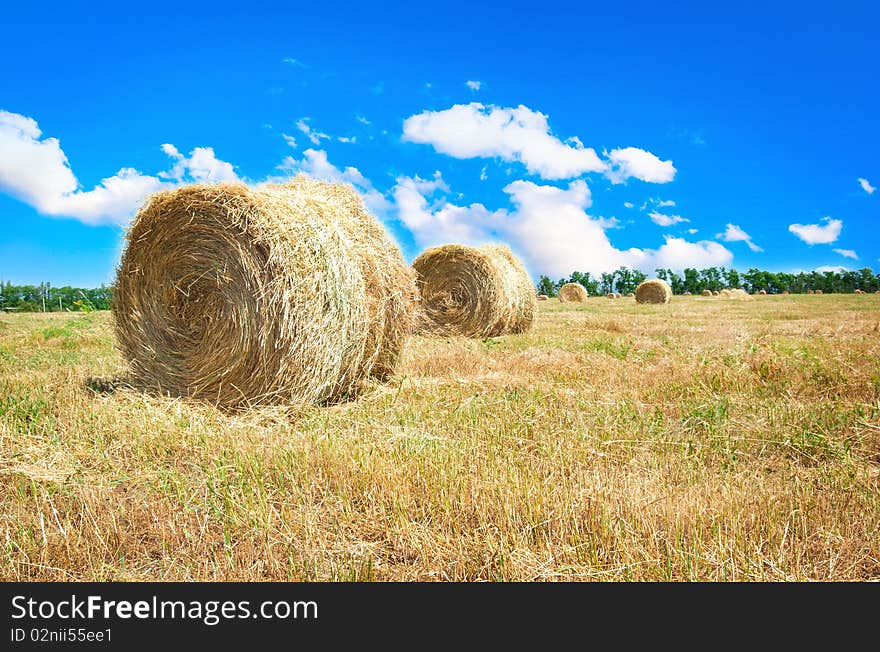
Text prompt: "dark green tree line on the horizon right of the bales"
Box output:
[[538, 267, 880, 296]]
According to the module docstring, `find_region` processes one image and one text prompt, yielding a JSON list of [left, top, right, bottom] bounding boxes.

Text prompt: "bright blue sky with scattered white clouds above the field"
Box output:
[[0, 2, 880, 286]]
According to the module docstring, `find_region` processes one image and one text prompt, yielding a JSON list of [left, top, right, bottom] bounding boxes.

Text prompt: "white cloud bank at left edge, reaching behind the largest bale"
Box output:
[[0, 111, 237, 224]]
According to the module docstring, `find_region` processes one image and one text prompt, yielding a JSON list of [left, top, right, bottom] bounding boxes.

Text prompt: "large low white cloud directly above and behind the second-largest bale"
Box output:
[[393, 173, 733, 277]]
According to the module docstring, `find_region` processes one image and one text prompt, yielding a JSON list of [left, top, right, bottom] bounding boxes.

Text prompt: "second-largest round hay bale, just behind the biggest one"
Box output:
[[413, 244, 537, 337]]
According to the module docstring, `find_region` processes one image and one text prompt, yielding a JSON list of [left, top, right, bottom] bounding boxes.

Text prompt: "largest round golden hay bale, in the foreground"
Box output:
[[113, 176, 416, 408]]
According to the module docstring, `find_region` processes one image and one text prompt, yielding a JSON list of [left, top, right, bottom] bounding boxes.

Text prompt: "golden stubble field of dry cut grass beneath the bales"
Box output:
[[0, 295, 880, 580]]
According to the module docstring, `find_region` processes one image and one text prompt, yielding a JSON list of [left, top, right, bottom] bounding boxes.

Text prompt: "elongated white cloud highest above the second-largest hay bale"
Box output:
[[403, 102, 605, 179]]
